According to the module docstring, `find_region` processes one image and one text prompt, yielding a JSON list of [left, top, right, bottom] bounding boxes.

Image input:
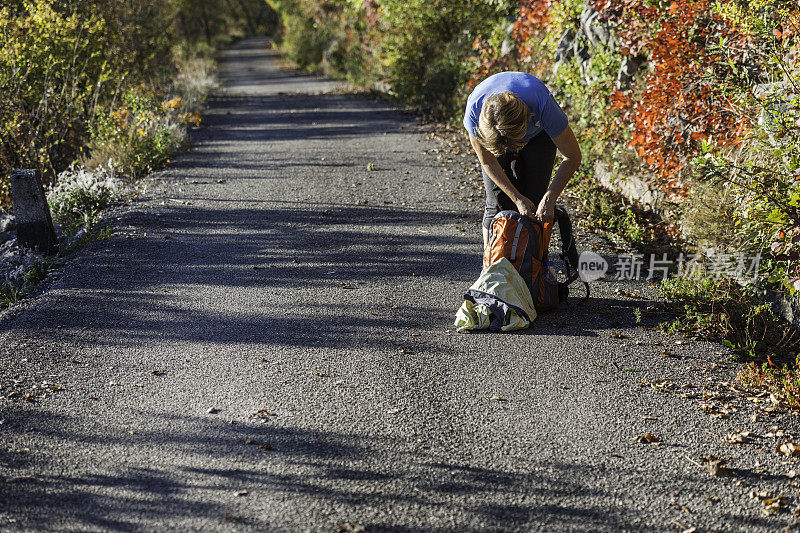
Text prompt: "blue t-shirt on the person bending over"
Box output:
[[464, 72, 568, 141]]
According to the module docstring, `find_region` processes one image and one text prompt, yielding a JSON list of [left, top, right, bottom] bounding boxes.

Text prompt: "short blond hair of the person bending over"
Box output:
[[473, 91, 531, 156]]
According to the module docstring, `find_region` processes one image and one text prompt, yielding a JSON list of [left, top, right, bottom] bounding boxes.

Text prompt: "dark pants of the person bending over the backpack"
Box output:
[[483, 131, 556, 228]]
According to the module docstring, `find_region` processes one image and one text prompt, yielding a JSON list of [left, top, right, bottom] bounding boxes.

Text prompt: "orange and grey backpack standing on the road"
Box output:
[[483, 206, 589, 312]]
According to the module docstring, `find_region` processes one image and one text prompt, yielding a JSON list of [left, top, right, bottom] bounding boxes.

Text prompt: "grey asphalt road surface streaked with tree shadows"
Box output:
[[0, 40, 798, 532]]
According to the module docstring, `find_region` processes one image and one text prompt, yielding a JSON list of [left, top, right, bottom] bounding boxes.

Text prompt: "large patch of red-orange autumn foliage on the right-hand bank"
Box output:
[[592, 0, 751, 196]]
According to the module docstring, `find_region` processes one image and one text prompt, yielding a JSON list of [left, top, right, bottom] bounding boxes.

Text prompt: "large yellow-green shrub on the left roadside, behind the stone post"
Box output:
[[0, 0, 277, 210]]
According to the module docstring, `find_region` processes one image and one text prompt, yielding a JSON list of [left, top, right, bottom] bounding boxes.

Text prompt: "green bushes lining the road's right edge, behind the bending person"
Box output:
[[268, 0, 515, 119]]
